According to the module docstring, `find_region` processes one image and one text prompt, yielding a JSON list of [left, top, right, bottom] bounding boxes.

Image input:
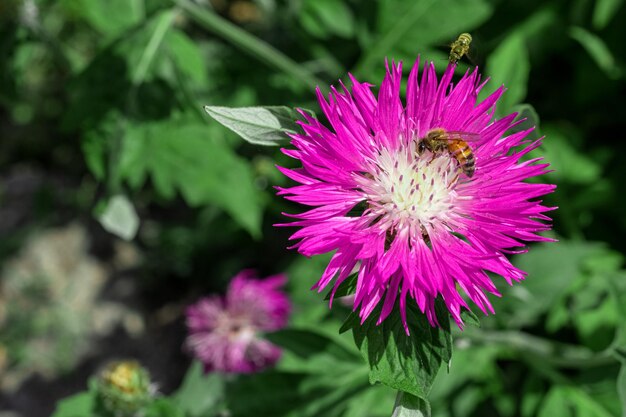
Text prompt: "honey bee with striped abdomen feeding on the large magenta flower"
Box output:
[[417, 128, 480, 178]]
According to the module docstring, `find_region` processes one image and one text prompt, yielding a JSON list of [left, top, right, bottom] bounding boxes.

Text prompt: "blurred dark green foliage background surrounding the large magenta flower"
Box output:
[[0, 0, 626, 417]]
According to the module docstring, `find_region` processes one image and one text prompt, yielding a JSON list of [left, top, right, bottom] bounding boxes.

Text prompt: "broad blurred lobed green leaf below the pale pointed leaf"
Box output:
[[118, 120, 263, 237]]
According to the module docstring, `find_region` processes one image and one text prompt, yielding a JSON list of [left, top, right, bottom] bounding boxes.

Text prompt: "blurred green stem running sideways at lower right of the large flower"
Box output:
[[463, 330, 617, 369]]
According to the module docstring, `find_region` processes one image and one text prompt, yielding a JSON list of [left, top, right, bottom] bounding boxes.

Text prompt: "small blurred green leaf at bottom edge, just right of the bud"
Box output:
[[172, 361, 224, 417]]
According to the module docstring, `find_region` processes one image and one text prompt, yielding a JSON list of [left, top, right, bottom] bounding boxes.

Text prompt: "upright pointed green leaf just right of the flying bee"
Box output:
[[481, 31, 530, 115]]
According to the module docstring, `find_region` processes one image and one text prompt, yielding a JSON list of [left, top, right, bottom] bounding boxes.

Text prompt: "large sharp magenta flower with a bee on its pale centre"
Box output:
[[279, 61, 554, 332]]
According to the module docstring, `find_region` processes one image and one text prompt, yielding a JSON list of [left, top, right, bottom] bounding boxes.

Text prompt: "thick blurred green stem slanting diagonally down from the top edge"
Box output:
[[173, 0, 325, 88]]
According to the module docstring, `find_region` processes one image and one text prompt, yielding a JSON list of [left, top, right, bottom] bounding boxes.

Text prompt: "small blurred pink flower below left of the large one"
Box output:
[[185, 271, 291, 373]]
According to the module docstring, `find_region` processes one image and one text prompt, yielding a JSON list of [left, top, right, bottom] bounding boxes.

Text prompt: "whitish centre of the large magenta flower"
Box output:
[[357, 142, 460, 233]]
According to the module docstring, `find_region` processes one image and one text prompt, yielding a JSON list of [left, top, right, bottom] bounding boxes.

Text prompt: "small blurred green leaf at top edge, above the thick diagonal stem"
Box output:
[[299, 0, 354, 39]]
